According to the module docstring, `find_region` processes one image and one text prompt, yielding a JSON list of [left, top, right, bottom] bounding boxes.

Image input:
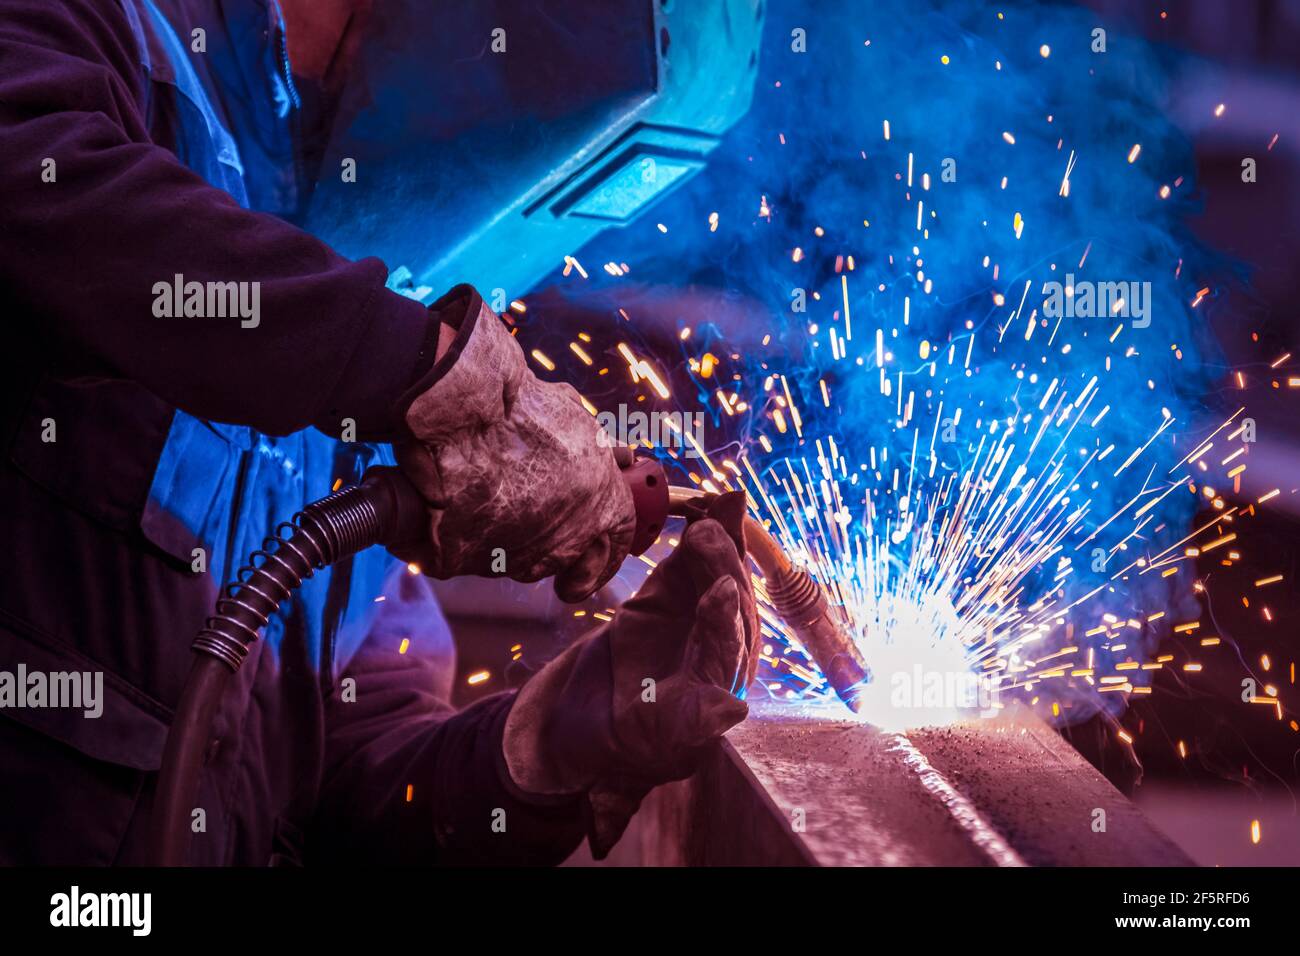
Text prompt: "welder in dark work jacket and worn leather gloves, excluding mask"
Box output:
[[0, 0, 758, 865]]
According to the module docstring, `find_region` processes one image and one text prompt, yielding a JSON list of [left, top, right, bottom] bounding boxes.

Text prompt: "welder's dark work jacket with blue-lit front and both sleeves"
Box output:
[[0, 0, 581, 865]]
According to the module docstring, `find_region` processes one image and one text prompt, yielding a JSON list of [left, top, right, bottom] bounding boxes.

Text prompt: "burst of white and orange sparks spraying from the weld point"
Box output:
[[534, 16, 1300, 758]]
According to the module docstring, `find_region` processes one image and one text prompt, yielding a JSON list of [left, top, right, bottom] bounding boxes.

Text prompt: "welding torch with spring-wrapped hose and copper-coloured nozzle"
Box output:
[[152, 447, 871, 866]]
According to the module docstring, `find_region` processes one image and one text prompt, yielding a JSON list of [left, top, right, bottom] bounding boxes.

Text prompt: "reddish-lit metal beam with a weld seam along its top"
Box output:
[[595, 700, 1192, 868]]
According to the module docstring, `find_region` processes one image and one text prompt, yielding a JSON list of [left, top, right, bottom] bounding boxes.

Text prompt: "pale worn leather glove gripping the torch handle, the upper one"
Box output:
[[394, 285, 636, 601]]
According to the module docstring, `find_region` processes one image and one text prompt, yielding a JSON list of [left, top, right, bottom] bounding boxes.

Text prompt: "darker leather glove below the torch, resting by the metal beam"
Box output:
[[503, 492, 759, 858]]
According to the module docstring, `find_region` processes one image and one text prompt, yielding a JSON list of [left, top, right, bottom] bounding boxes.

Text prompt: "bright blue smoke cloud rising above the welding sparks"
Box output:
[[556, 0, 1217, 719]]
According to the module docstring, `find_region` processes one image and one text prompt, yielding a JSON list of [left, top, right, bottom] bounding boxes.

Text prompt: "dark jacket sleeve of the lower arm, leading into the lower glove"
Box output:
[[307, 574, 586, 865]]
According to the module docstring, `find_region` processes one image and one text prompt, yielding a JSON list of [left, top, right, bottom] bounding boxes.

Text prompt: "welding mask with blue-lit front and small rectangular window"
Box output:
[[304, 0, 763, 300]]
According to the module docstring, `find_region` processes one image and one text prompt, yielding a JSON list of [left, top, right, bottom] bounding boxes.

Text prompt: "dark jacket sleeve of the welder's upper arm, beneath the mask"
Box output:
[[0, 0, 437, 438]]
